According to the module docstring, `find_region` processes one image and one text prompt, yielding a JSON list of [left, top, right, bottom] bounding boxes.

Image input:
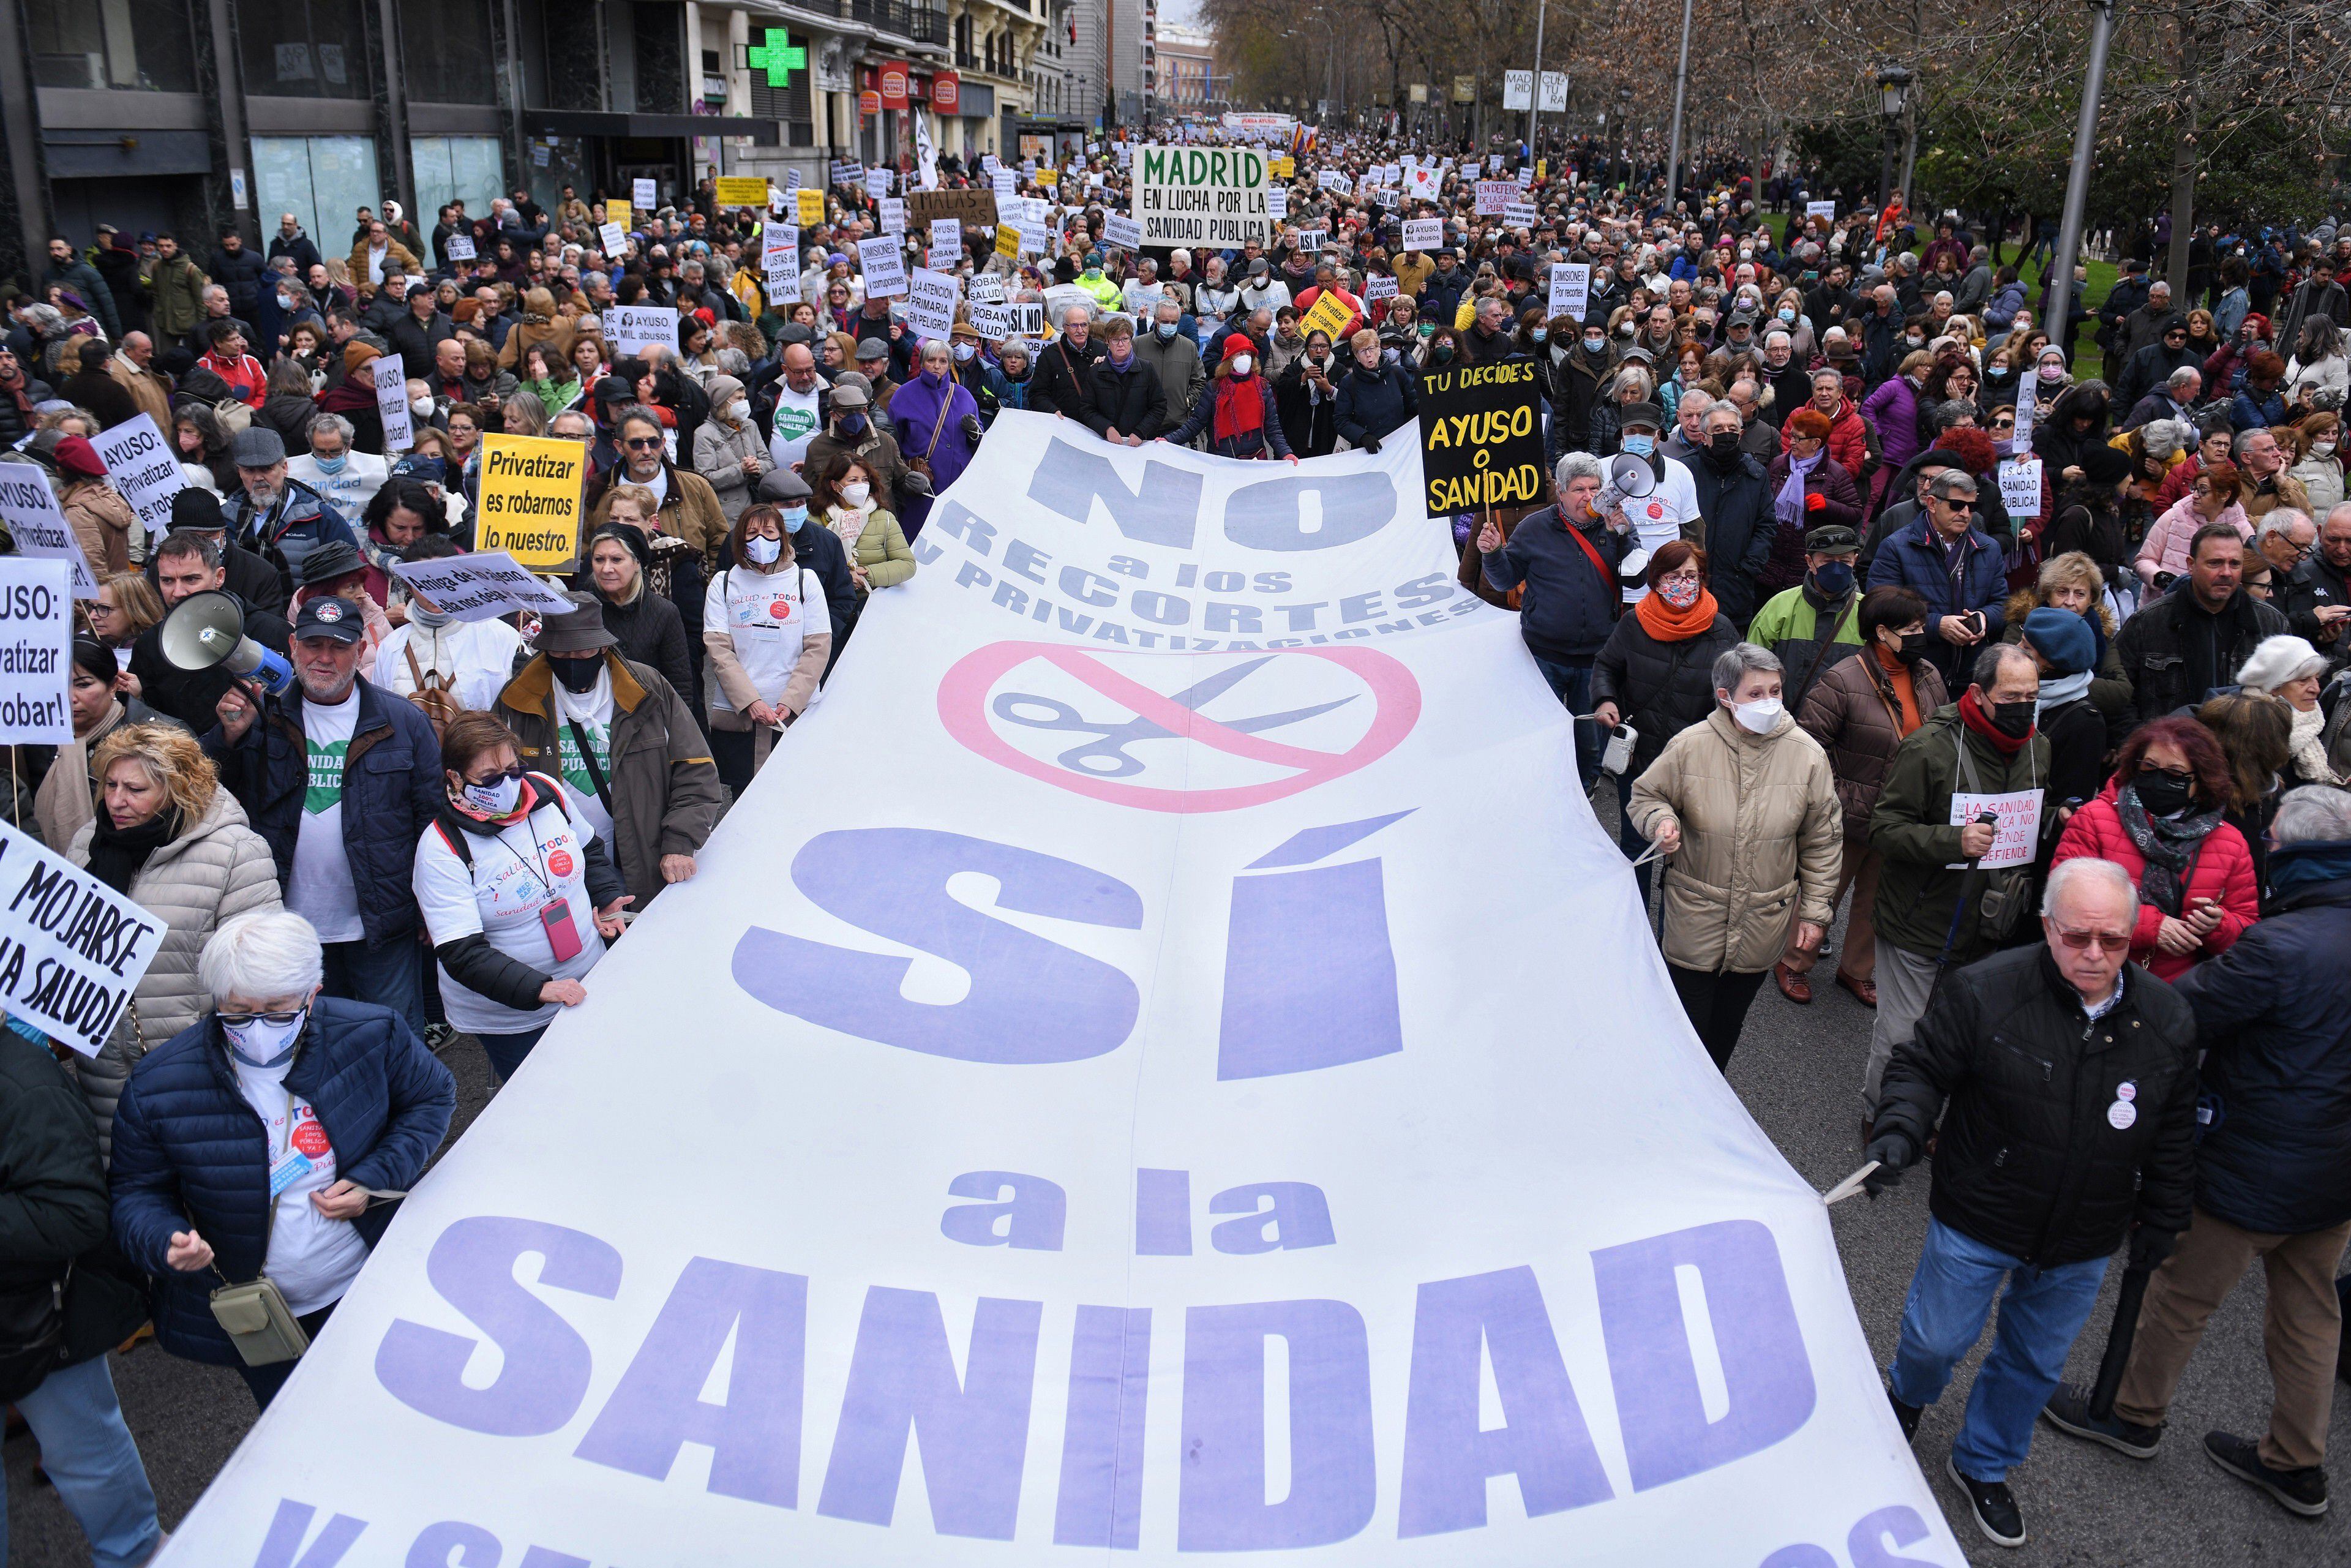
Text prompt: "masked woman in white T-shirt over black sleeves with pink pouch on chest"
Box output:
[[414, 712, 632, 1084]]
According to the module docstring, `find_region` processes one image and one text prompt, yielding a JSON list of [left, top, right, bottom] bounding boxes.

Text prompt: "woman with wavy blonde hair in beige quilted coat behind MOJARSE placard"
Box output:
[[66, 724, 277, 1157]]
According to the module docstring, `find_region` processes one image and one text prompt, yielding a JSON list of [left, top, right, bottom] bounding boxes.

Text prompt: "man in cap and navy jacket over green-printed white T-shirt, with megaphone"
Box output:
[[204, 595, 444, 1034]]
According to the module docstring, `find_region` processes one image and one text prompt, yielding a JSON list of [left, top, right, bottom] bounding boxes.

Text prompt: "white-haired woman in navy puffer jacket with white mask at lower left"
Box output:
[[113, 910, 456, 1408]]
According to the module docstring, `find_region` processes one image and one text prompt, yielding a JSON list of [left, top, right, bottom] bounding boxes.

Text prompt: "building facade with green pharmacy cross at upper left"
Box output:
[[0, 0, 1058, 272]]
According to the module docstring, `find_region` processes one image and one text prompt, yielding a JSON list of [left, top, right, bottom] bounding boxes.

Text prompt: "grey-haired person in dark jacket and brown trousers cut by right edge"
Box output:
[[2048, 785, 2351, 1518]]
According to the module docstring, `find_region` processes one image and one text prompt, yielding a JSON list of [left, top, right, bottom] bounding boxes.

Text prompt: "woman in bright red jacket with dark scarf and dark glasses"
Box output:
[[2050, 719, 2259, 980]]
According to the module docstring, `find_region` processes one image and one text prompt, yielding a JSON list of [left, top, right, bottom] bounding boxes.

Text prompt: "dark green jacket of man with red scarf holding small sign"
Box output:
[[1869, 703, 2050, 966]]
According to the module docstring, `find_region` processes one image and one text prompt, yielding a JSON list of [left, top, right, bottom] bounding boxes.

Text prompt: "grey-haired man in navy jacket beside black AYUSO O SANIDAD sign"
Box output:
[[1477, 451, 1638, 795]]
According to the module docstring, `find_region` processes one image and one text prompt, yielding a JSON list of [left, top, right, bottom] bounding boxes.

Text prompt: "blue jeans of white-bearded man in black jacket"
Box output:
[[1888, 1220, 2107, 1481]]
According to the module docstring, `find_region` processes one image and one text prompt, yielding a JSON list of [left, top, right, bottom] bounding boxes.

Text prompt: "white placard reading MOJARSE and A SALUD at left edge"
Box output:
[[0, 823, 169, 1056]]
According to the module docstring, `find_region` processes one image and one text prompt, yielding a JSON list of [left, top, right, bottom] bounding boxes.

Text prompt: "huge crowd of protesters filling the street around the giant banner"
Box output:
[[0, 122, 2351, 1566]]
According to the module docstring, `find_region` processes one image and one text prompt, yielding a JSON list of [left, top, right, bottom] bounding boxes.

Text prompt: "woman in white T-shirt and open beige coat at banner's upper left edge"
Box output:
[[703, 501, 832, 797]]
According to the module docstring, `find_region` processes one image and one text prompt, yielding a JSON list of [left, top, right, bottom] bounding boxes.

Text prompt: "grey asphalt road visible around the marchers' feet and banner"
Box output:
[[7, 879, 2351, 1568]]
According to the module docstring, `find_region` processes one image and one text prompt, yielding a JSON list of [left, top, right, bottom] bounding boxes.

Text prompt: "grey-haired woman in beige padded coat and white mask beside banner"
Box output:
[[1627, 642, 1843, 1070]]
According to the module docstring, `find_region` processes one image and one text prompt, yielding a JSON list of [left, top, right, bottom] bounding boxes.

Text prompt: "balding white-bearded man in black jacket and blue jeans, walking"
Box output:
[[1869, 860, 2196, 1547]]
